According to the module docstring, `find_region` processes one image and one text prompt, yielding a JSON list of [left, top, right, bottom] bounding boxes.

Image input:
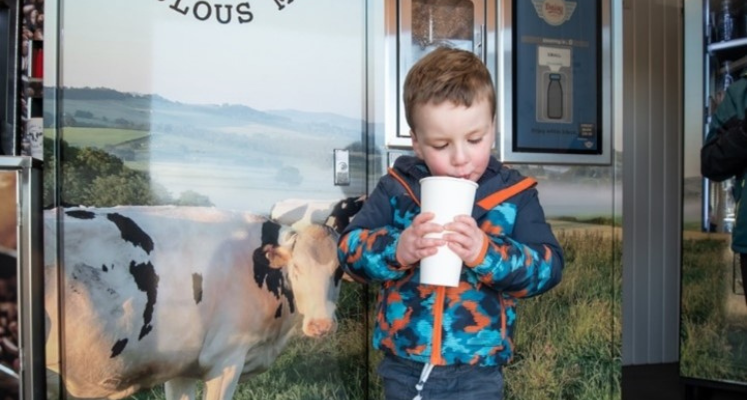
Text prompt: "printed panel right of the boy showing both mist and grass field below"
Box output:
[[505, 163, 622, 400]]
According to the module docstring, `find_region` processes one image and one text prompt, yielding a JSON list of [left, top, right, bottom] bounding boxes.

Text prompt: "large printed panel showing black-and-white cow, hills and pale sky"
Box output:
[[44, 0, 368, 399]]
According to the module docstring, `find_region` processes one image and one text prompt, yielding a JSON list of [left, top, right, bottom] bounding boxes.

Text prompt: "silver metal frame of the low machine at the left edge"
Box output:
[[0, 157, 46, 399]]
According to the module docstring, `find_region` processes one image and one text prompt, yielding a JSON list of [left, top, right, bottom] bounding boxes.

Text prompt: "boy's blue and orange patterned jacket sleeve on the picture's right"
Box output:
[[464, 188, 564, 297]]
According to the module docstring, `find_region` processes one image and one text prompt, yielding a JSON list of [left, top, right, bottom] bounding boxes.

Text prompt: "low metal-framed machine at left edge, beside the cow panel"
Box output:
[[0, 156, 46, 399]]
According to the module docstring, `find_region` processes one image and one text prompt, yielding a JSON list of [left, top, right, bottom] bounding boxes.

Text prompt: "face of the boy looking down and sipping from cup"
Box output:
[[410, 100, 495, 182]]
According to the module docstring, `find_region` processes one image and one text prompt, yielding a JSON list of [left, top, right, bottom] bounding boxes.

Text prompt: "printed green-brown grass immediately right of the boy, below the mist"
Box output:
[[505, 231, 622, 400]]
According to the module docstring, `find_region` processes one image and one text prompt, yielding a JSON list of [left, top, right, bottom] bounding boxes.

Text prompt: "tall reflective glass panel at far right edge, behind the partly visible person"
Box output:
[[680, 0, 747, 384]]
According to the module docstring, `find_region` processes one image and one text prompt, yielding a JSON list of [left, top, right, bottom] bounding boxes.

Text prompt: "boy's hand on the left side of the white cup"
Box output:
[[397, 212, 446, 265]]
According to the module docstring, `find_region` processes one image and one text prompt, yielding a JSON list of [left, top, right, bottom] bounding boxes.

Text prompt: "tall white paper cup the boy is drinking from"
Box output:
[[420, 176, 477, 287]]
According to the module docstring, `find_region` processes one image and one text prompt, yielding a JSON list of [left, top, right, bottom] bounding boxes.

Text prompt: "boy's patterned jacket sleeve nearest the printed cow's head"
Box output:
[[337, 182, 408, 283]]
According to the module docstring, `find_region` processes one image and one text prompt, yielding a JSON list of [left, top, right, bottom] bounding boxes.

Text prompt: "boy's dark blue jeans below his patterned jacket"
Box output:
[[376, 355, 503, 400]]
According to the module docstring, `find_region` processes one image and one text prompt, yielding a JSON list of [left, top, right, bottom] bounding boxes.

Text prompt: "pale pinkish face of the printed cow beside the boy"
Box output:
[[265, 224, 342, 337]]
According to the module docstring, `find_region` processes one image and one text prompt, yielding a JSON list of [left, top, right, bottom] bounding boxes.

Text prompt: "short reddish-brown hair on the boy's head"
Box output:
[[403, 47, 496, 130]]
